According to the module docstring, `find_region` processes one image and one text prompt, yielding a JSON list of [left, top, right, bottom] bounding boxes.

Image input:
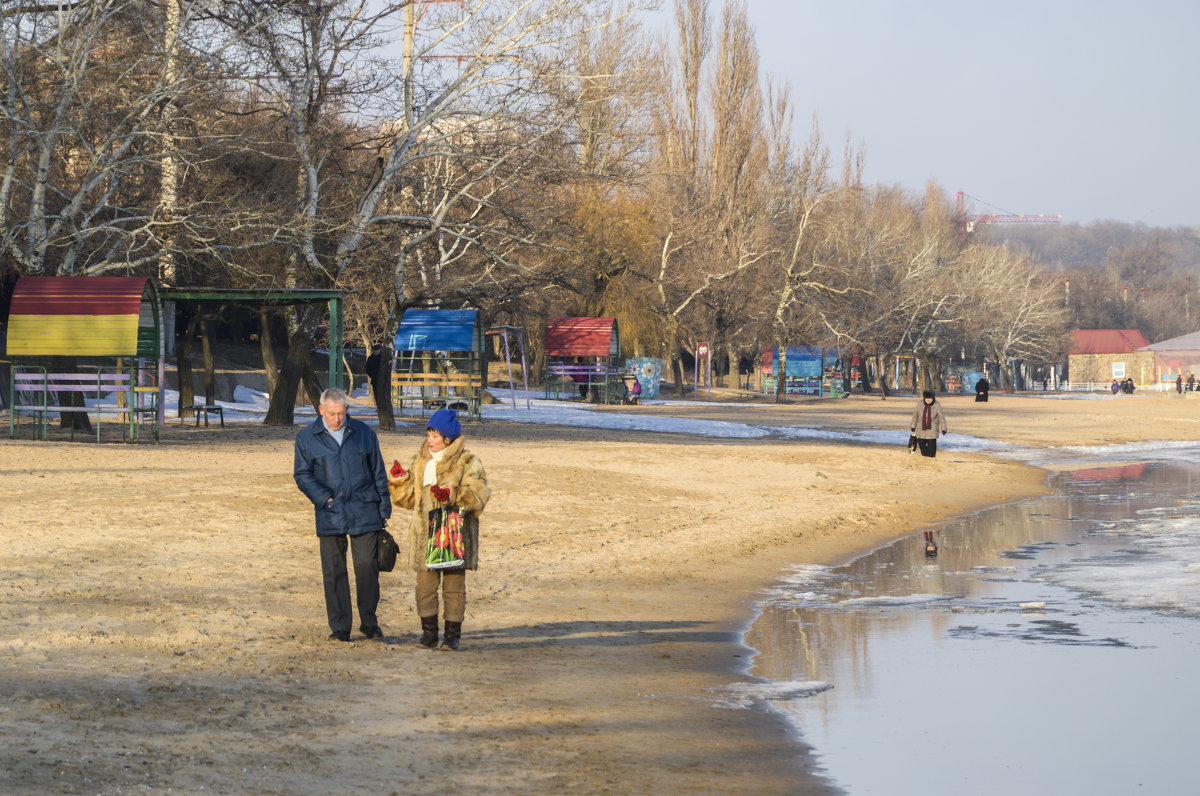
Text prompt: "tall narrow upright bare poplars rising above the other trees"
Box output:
[[646, 0, 769, 393]]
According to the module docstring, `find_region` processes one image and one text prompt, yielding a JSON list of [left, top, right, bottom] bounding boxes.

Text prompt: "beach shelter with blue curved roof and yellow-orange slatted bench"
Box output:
[[391, 309, 485, 420]]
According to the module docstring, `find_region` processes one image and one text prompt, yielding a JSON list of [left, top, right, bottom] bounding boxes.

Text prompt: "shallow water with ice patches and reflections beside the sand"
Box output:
[[746, 451, 1200, 796]]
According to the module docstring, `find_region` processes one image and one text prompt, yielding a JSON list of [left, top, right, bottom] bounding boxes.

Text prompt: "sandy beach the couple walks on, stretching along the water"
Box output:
[[0, 394, 1200, 794]]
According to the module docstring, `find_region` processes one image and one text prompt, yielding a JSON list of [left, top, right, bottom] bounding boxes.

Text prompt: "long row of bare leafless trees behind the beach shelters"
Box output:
[[0, 0, 1068, 427]]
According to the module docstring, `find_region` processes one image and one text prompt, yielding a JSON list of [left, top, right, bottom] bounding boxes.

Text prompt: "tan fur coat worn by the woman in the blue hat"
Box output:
[[388, 437, 492, 571]]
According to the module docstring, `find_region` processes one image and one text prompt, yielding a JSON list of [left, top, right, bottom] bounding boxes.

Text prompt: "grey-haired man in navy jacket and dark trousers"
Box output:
[[293, 389, 391, 641]]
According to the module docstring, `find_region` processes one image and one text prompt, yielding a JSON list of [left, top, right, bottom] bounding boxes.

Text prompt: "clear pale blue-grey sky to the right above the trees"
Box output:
[[664, 0, 1200, 228]]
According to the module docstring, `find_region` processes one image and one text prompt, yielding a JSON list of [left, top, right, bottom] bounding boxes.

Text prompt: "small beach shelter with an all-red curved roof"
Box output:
[[546, 317, 625, 403]]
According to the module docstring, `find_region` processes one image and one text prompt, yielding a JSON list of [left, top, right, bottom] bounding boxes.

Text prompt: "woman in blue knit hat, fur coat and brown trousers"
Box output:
[[388, 409, 491, 650]]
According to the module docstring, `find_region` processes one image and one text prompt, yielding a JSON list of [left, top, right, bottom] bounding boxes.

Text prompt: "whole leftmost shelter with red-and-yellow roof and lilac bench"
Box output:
[[7, 276, 166, 442]]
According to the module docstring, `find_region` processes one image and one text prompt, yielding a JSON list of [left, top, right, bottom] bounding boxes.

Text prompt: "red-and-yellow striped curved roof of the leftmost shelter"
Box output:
[[8, 276, 162, 357]]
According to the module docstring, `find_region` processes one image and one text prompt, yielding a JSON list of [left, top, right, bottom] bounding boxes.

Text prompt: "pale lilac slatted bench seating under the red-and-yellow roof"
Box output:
[[8, 366, 158, 442]]
